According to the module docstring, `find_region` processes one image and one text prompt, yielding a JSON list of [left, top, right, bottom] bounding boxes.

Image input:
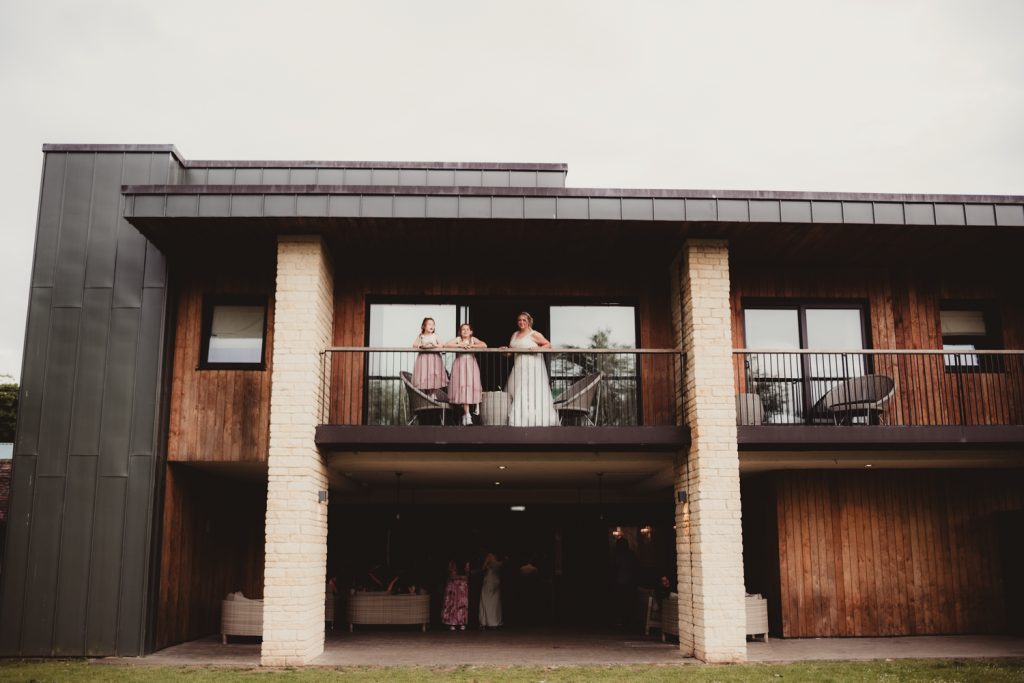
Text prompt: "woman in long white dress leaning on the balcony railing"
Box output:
[[506, 311, 558, 427]]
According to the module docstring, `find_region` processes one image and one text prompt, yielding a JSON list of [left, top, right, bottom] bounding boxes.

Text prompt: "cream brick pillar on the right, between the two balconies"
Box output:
[[673, 240, 746, 663]]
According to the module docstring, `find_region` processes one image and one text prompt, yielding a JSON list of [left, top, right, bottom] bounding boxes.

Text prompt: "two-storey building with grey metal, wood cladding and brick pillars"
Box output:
[[0, 144, 1024, 664]]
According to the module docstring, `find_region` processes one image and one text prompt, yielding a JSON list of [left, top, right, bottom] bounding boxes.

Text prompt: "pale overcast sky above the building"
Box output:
[[0, 0, 1024, 377]]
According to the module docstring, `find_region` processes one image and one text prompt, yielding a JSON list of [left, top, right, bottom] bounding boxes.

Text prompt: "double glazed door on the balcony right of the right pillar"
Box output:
[[743, 303, 868, 424]]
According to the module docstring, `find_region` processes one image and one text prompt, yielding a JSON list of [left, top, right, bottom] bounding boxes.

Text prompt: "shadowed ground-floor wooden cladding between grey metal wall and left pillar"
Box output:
[[157, 464, 266, 649]]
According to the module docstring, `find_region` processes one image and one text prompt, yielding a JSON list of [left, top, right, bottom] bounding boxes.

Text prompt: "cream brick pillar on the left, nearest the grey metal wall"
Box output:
[[260, 236, 334, 667]]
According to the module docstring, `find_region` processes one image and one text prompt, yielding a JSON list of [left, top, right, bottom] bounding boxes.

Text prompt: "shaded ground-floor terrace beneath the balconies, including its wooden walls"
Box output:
[[156, 452, 1024, 666]]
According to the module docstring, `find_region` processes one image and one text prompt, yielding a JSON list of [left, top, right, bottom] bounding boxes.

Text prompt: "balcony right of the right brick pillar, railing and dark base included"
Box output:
[[733, 349, 1024, 449]]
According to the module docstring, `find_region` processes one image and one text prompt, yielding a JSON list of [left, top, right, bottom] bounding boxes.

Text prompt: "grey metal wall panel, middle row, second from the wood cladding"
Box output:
[[99, 308, 139, 477]]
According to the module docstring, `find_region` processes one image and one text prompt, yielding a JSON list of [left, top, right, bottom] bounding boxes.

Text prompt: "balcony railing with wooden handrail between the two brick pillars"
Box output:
[[321, 347, 684, 427]]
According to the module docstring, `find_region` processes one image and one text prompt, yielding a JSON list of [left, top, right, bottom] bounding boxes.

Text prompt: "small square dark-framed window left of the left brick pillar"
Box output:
[[200, 296, 266, 370]]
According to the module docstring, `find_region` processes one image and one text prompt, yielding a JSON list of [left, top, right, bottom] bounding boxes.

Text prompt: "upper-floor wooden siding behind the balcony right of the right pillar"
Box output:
[[730, 264, 1024, 425]]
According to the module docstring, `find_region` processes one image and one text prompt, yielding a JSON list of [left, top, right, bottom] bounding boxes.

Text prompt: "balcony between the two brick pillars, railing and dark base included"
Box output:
[[316, 347, 689, 451]]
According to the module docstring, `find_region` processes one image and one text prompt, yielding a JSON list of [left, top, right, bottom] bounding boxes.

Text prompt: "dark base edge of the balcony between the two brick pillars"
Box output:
[[316, 425, 690, 452]]
